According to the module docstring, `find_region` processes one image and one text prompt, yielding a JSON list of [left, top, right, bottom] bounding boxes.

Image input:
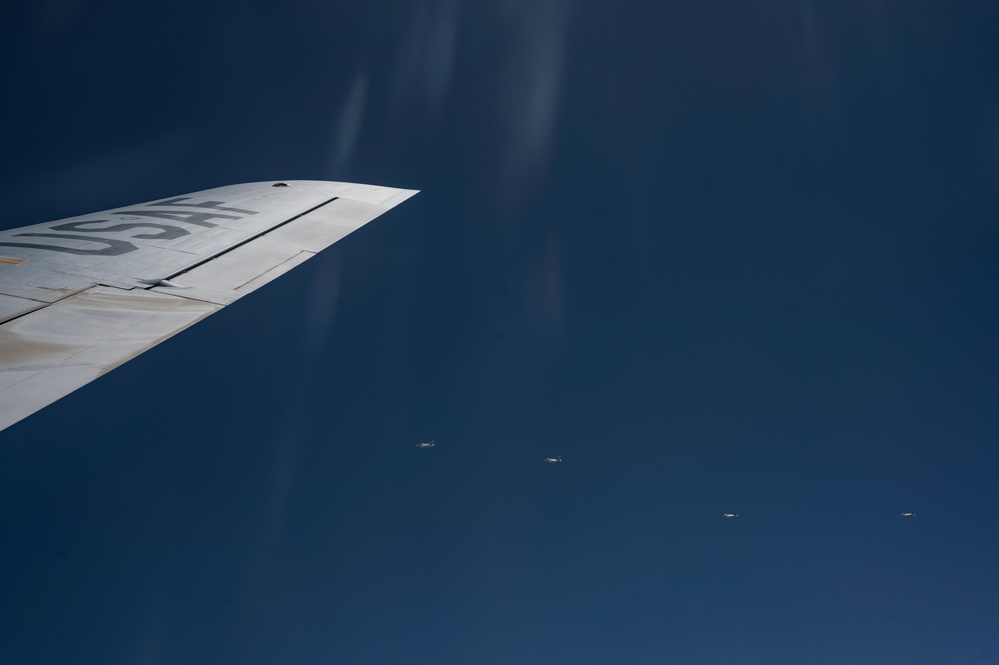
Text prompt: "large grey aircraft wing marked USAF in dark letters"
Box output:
[[0, 181, 416, 429]]
